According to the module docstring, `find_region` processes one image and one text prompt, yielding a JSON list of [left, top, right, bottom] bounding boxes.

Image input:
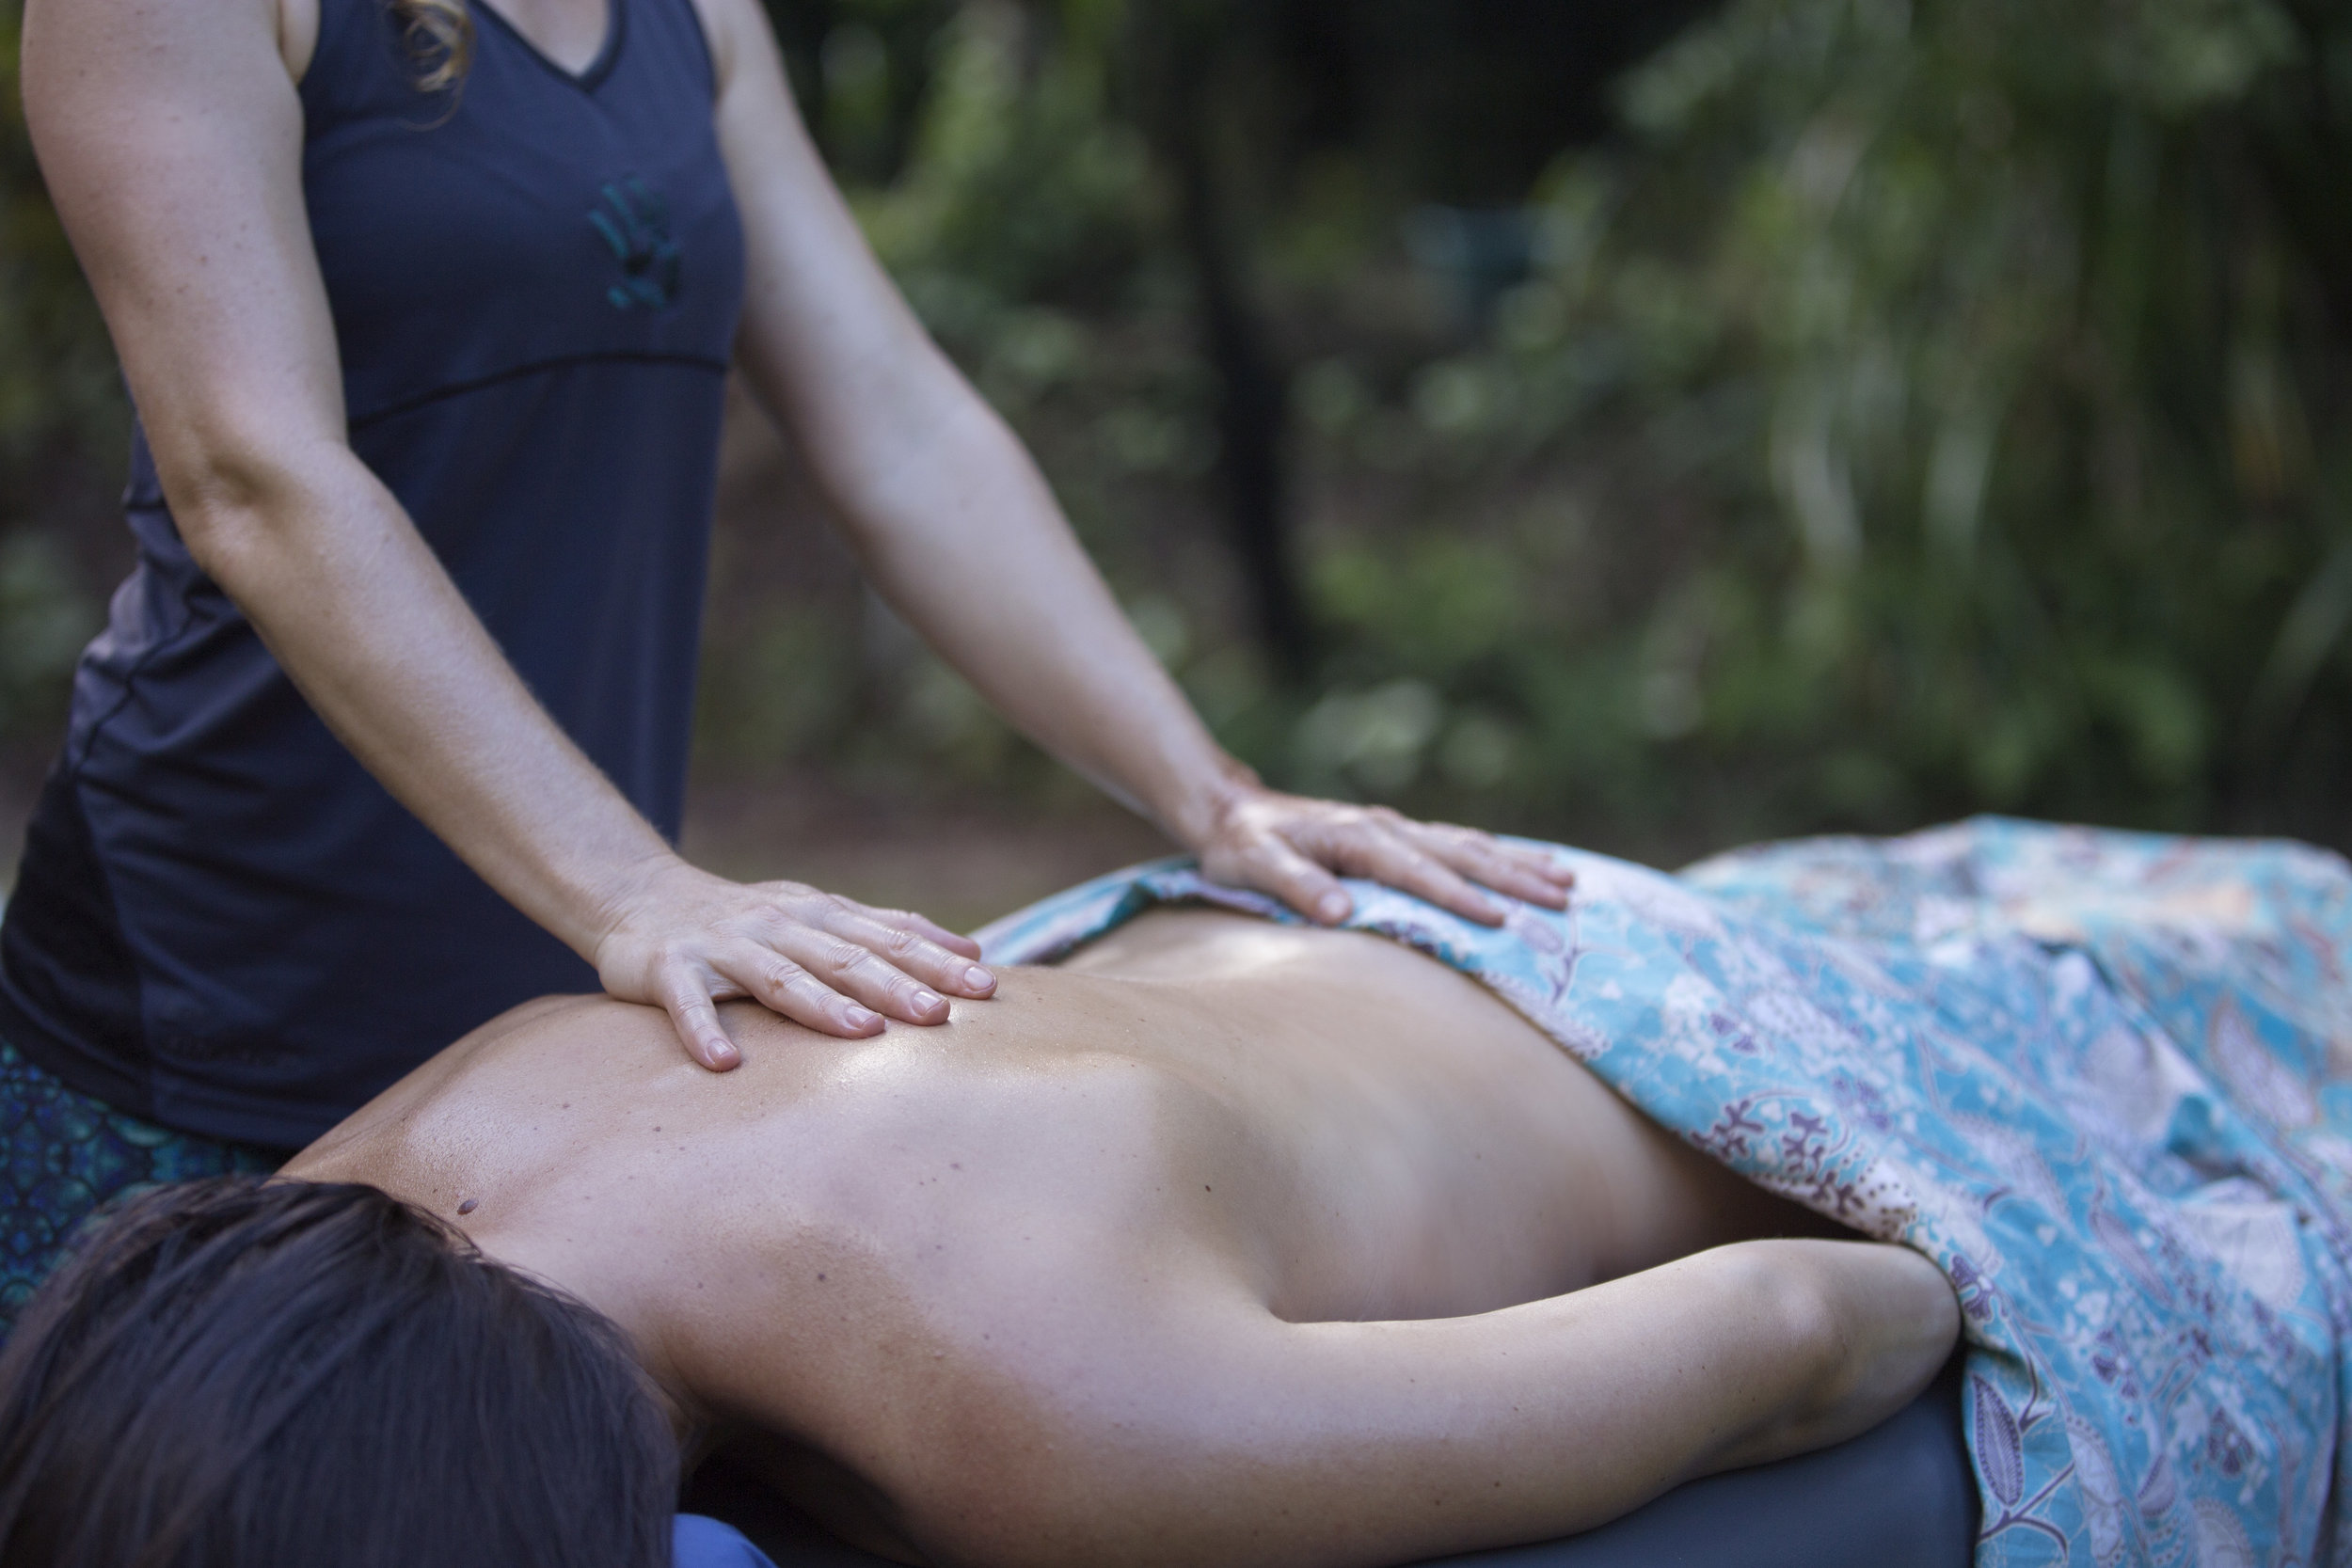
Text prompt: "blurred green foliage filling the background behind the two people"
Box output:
[[13, 0, 2352, 853]]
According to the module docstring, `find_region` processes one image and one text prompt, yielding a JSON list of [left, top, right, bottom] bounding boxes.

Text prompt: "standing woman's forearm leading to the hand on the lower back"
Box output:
[[835, 395, 1249, 844]]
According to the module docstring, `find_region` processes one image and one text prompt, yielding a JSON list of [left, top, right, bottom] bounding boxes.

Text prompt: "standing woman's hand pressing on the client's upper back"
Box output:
[[593, 856, 997, 1072]]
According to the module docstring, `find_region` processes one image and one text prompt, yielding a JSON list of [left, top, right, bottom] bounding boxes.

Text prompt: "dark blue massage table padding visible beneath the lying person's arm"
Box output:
[[677, 1359, 1979, 1568]]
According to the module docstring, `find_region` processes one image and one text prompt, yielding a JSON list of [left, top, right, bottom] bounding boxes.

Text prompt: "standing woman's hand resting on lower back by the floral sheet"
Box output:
[[1193, 783, 1576, 927]]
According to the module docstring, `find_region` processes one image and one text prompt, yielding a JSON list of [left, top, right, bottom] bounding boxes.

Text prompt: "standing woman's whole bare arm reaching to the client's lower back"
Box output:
[[701, 0, 1569, 924]]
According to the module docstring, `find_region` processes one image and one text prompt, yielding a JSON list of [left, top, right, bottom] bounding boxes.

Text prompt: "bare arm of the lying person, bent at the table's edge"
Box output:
[[889, 1242, 1960, 1568]]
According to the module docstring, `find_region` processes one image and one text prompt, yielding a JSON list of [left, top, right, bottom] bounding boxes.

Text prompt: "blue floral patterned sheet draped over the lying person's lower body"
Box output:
[[978, 818, 2352, 1568]]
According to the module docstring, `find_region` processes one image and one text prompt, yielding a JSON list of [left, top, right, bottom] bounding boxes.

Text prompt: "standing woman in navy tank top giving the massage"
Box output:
[[0, 0, 1562, 1319]]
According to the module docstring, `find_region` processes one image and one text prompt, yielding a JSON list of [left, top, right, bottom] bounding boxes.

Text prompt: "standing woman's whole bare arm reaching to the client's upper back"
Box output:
[[24, 0, 993, 1068]]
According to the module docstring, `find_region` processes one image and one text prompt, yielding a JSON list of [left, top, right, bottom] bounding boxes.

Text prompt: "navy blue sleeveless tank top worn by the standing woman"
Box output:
[[0, 0, 743, 1145]]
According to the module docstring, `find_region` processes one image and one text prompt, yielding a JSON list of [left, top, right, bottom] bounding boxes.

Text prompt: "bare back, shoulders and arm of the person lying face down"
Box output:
[[287, 910, 1957, 1568]]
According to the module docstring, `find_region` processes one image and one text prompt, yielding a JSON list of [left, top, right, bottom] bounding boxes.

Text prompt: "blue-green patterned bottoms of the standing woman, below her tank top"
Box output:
[[0, 1041, 294, 1340]]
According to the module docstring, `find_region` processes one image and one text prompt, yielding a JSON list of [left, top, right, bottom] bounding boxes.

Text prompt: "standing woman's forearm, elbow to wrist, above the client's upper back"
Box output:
[[167, 442, 668, 957]]
